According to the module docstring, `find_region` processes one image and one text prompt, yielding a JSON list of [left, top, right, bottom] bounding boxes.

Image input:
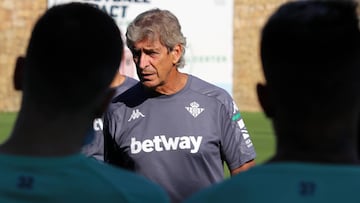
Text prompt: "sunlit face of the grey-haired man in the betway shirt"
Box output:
[[131, 39, 177, 90]]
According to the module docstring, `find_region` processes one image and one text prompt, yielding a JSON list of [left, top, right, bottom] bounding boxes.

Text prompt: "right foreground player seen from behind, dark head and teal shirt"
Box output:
[[186, 0, 360, 203]]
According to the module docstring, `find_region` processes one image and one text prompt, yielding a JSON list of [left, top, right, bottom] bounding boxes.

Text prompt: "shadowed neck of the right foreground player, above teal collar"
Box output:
[[274, 114, 358, 164]]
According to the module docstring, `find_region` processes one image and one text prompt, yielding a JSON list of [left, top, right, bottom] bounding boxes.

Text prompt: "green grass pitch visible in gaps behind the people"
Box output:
[[0, 112, 275, 176]]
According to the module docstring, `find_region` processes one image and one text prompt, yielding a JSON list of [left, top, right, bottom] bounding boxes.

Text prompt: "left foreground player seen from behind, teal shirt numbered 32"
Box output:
[[0, 3, 168, 203]]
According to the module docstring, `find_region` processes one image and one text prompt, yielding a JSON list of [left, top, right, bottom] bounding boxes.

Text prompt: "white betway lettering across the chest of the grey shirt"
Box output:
[[130, 135, 202, 154]]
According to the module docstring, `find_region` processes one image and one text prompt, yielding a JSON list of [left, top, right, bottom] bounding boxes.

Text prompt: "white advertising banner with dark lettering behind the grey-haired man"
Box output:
[[48, 0, 234, 94]]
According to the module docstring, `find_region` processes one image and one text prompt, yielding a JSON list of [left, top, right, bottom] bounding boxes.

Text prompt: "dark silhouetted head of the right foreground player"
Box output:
[[258, 0, 360, 119]]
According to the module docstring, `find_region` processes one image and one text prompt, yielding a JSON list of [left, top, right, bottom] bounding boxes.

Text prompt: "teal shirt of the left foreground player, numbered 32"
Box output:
[[0, 154, 168, 203]]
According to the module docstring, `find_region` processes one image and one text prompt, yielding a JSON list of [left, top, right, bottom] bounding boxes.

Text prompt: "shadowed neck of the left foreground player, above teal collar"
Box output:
[[0, 109, 86, 156]]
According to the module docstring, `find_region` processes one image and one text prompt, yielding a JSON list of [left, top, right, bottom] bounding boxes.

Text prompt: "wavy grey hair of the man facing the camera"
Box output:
[[126, 9, 186, 68]]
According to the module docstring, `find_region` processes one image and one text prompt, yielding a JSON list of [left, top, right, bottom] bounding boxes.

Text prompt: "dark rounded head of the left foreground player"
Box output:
[[18, 3, 123, 112]]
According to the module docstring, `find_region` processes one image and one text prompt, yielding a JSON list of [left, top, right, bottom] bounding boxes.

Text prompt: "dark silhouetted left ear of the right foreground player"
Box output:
[[256, 83, 276, 118]]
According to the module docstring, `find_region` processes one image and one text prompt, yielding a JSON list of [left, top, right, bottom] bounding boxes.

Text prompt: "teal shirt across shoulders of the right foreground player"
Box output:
[[185, 162, 360, 203]]
